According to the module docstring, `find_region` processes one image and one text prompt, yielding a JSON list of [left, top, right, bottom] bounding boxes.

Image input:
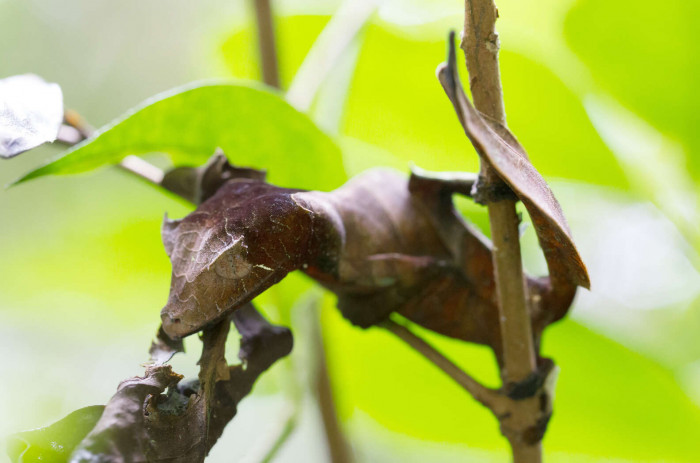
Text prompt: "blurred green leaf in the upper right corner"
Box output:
[[565, 0, 700, 180]]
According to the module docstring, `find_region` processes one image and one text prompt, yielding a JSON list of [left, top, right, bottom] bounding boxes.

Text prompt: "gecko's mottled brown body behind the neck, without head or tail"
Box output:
[[303, 169, 576, 358]]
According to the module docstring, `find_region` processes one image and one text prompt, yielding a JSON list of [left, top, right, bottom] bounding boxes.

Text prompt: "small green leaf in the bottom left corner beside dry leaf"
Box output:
[[7, 405, 104, 463]]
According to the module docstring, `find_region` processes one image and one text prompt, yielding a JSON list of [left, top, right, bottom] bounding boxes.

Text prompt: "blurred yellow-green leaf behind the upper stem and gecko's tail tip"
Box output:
[[344, 21, 626, 187]]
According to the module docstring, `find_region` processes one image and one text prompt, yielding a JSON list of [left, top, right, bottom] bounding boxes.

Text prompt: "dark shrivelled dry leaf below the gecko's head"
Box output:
[[70, 304, 292, 463]]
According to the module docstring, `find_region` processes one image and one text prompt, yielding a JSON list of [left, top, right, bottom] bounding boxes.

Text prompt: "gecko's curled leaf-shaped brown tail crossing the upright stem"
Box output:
[[437, 33, 590, 291]]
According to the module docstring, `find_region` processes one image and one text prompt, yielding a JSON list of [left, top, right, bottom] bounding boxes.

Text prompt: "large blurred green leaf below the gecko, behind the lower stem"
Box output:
[[324, 304, 700, 463]]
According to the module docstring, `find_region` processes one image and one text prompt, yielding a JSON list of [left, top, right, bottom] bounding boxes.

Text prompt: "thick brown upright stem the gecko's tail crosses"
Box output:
[[462, 0, 542, 463]]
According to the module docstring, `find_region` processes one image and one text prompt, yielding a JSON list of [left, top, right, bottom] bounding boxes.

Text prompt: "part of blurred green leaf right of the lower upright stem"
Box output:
[[543, 320, 700, 462]]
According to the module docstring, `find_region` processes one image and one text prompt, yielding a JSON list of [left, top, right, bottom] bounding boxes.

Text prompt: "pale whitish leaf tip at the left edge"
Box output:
[[0, 74, 63, 158]]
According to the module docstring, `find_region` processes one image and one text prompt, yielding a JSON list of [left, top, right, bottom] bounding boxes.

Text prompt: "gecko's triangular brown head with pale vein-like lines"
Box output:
[[161, 180, 313, 339]]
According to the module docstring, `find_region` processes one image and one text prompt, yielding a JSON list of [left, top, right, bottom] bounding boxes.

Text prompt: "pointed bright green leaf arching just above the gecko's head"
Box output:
[[16, 83, 345, 189]]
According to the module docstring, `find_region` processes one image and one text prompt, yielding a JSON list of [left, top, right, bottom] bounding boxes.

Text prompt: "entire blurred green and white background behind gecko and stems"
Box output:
[[0, 0, 700, 462]]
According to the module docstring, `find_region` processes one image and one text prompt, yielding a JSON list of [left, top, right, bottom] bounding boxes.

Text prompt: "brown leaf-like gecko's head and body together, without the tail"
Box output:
[[162, 169, 575, 357]]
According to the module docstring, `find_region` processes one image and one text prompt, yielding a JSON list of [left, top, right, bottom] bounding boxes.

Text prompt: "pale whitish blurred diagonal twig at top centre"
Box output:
[[287, 0, 377, 111]]
